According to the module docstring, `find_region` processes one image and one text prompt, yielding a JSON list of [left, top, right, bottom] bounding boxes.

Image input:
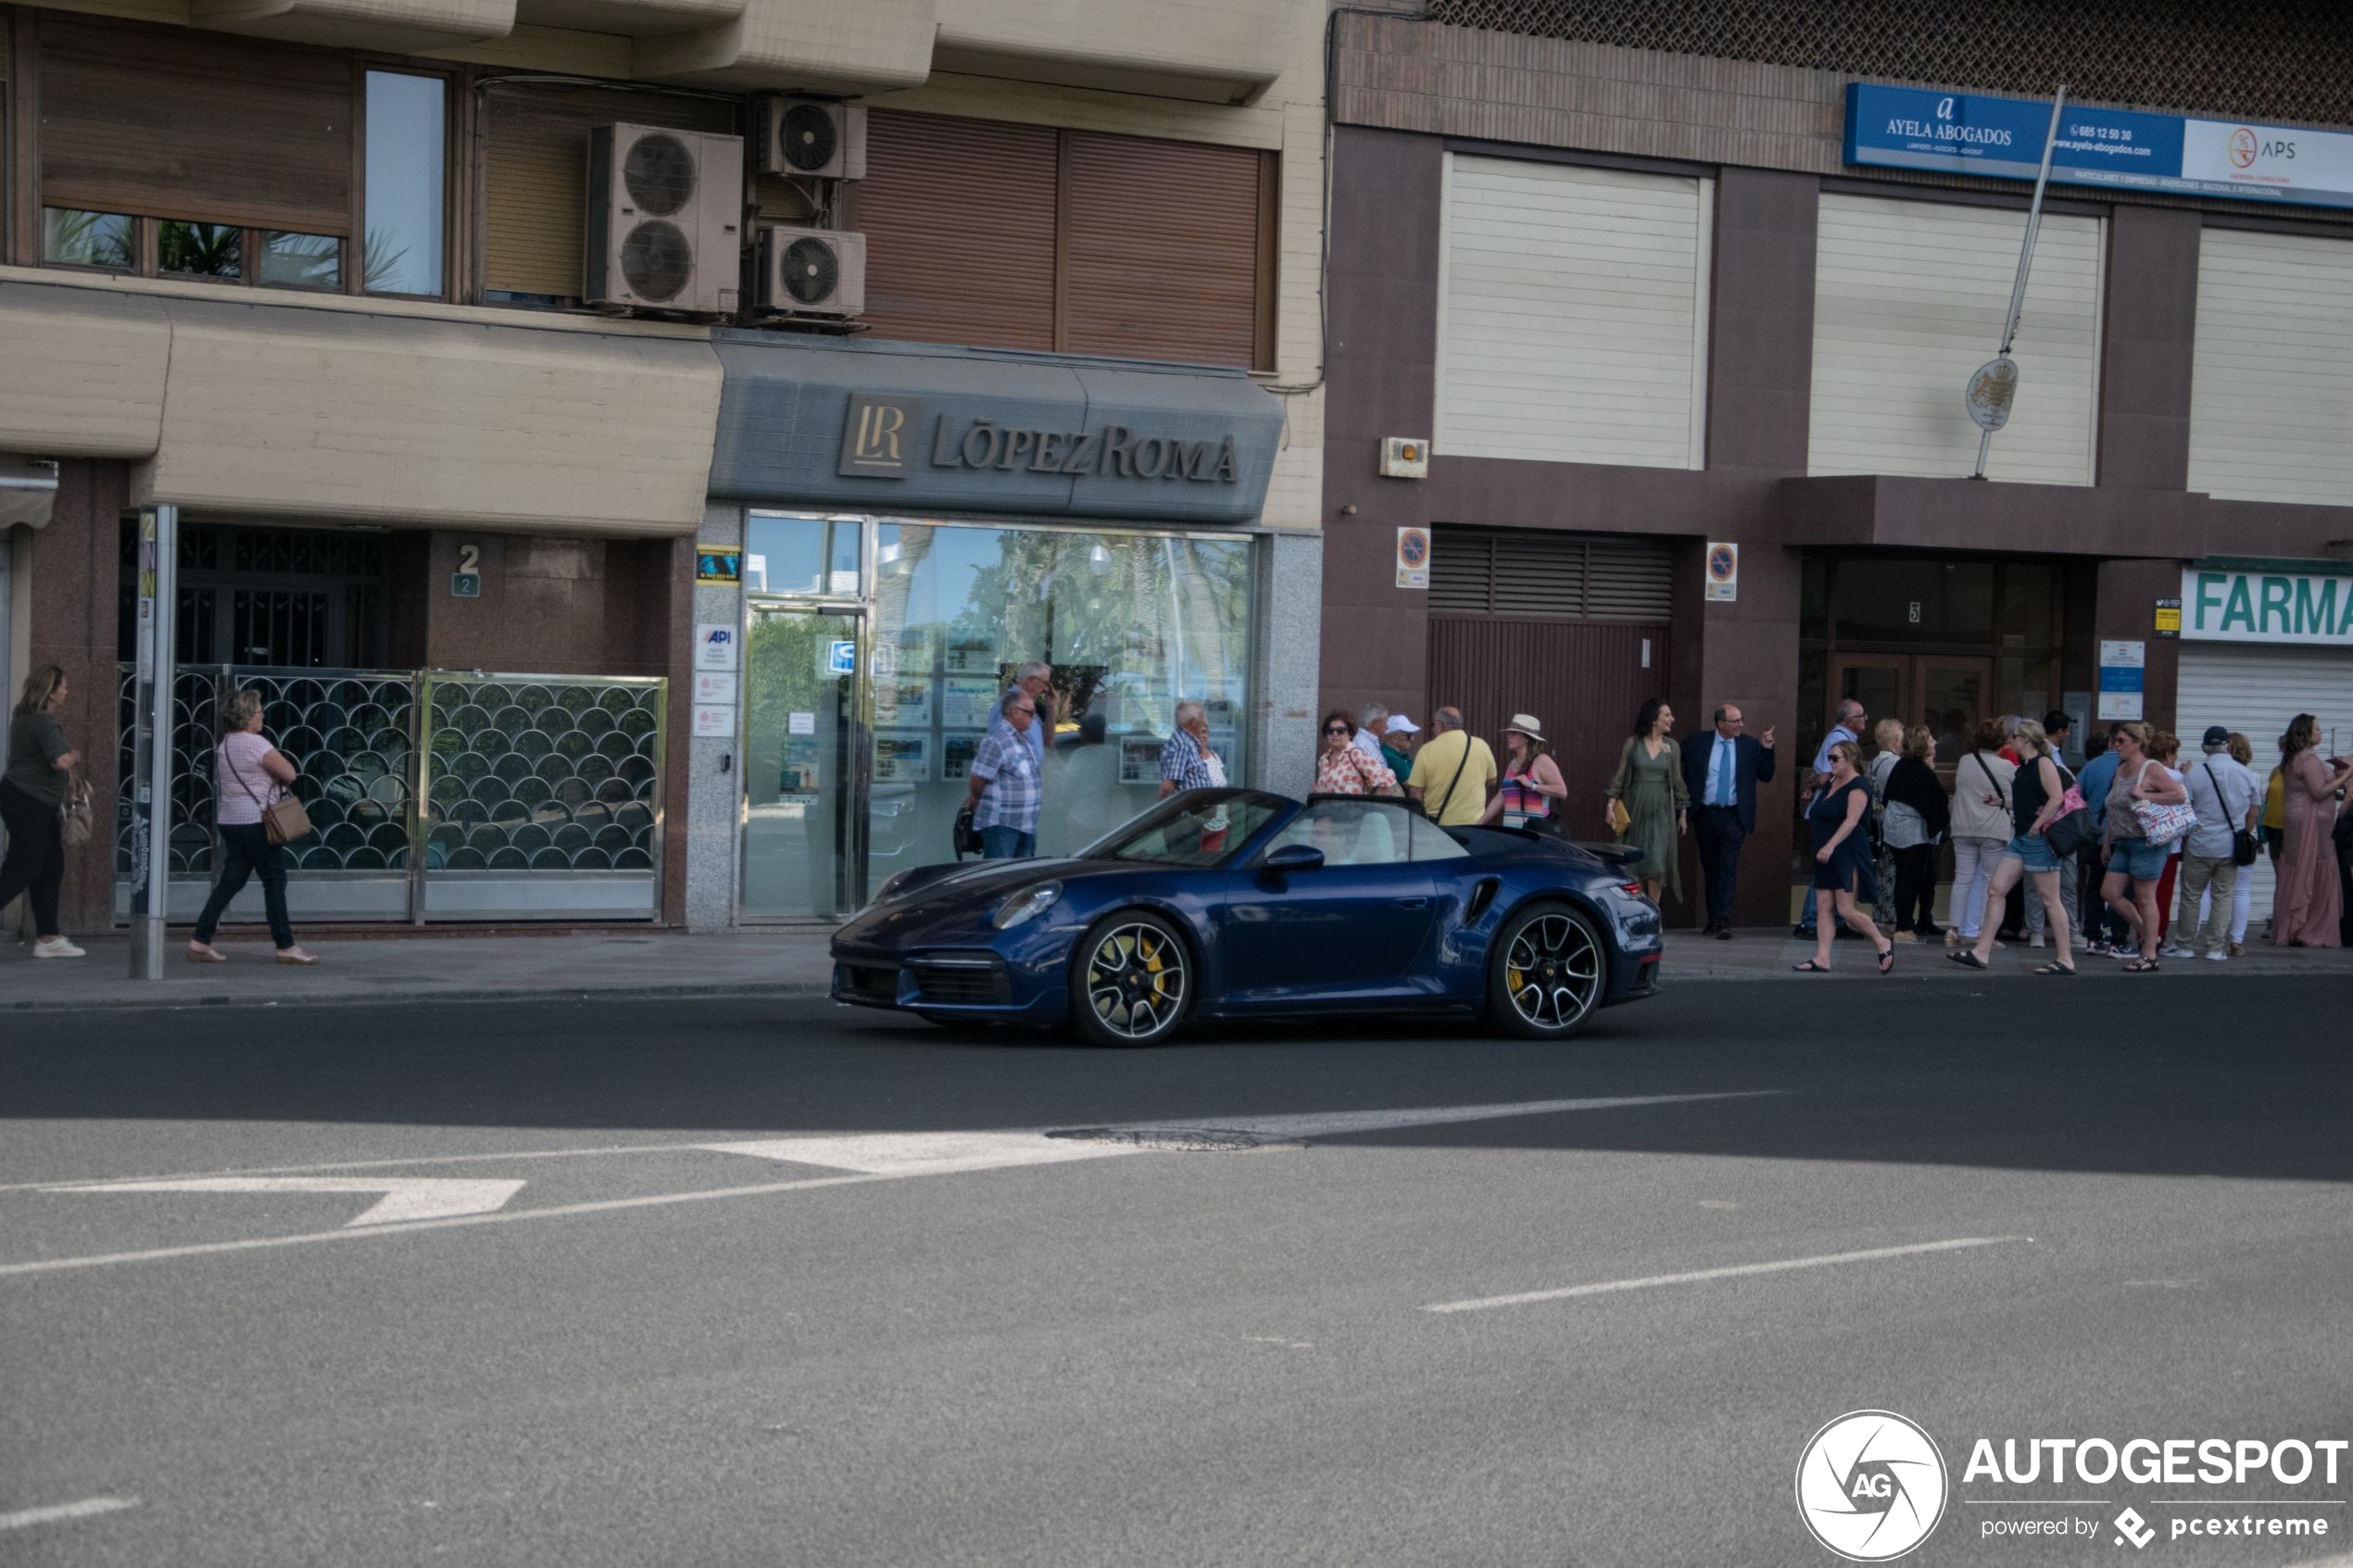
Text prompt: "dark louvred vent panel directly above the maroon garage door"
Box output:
[[1430, 527, 1675, 623]]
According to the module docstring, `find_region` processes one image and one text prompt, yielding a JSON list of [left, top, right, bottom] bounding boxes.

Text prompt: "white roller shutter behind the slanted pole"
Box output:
[[1807, 193, 2106, 484]]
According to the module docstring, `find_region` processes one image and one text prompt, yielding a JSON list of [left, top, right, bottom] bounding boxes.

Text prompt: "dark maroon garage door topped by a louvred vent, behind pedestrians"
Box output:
[[1416, 527, 1699, 839]]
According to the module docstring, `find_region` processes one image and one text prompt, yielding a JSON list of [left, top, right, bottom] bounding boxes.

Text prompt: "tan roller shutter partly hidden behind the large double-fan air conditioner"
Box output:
[[483, 87, 736, 298]]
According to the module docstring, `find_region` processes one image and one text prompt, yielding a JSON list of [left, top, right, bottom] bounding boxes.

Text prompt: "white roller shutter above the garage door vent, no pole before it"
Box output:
[[1433, 153, 1716, 468]]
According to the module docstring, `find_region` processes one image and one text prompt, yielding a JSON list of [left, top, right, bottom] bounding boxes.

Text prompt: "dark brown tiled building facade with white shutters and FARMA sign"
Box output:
[[1322, 0, 2353, 924]]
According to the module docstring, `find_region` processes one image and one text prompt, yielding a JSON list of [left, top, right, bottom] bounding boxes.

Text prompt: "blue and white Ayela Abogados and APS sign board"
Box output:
[[1847, 82, 2353, 207]]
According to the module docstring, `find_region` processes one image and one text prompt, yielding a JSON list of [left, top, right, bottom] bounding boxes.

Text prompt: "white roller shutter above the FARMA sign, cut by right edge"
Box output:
[[2191, 228, 2353, 506]]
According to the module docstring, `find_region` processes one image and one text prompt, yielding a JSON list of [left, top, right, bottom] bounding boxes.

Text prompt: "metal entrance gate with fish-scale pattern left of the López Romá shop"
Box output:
[[115, 665, 668, 922]]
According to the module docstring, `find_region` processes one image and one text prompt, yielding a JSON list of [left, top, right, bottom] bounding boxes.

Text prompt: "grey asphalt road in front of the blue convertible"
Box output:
[[0, 973, 2353, 1568]]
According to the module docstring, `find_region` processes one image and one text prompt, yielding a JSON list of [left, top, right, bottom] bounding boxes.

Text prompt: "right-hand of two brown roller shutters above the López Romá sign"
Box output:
[[1063, 132, 1266, 364]]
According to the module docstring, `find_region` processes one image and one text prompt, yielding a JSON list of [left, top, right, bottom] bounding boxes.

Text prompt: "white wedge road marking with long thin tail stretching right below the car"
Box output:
[[701, 1088, 1786, 1175]]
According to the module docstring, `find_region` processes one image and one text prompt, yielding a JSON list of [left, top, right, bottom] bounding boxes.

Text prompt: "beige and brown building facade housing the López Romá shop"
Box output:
[[0, 0, 1325, 931]]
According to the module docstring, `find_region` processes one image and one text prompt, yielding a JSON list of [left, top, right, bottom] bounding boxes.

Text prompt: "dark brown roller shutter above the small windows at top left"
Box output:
[[35, 12, 358, 235]]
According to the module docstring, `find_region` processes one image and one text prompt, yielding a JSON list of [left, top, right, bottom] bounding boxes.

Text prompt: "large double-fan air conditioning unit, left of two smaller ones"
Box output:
[[585, 125, 744, 315]]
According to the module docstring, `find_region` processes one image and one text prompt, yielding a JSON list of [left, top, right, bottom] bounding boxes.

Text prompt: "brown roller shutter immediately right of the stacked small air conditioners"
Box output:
[[849, 108, 1056, 350]]
